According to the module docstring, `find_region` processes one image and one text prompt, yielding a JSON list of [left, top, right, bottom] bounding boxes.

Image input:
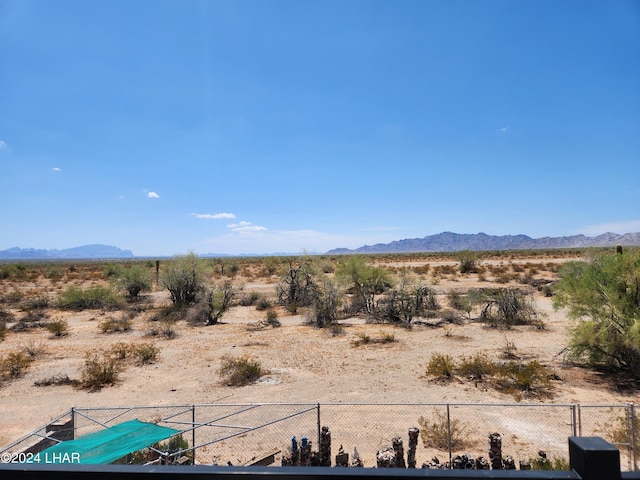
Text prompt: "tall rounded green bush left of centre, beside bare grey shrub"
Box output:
[[160, 252, 203, 307]]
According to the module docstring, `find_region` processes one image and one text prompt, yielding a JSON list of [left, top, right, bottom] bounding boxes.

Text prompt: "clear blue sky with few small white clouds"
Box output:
[[0, 0, 640, 255]]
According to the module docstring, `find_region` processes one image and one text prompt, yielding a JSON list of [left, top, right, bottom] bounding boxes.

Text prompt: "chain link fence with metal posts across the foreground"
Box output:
[[0, 403, 640, 470]]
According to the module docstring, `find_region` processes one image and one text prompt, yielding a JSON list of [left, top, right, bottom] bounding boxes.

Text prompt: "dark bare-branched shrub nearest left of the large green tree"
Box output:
[[480, 288, 544, 328]]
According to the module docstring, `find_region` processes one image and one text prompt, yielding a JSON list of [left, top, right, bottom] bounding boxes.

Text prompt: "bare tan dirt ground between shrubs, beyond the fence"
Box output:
[[0, 258, 638, 465]]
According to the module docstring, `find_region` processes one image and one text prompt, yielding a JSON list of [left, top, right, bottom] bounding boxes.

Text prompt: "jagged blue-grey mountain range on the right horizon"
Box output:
[[327, 232, 640, 255]]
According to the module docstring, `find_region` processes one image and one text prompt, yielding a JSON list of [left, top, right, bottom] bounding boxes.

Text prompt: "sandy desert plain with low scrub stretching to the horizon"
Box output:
[[0, 250, 638, 467]]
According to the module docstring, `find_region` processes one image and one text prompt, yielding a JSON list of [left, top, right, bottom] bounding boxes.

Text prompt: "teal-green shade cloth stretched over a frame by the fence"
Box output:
[[34, 420, 180, 464]]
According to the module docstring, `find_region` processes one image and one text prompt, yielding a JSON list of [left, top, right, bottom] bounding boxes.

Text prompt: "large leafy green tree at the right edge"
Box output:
[[553, 250, 640, 378]]
